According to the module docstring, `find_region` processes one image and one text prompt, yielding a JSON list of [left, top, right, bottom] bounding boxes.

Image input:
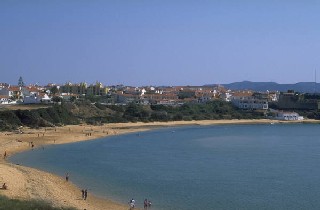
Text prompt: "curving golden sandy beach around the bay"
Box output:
[[0, 119, 319, 210]]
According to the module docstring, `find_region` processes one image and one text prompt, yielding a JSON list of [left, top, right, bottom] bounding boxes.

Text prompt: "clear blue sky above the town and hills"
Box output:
[[0, 0, 320, 86]]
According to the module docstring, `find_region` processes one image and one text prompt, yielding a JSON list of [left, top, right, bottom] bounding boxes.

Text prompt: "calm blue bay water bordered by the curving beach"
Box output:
[[10, 124, 320, 210]]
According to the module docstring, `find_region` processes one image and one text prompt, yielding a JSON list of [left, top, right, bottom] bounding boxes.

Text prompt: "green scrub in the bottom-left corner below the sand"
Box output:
[[0, 196, 75, 210]]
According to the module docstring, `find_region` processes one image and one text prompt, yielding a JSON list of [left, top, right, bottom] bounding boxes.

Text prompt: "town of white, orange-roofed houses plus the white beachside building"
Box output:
[[0, 82, 316, 120]]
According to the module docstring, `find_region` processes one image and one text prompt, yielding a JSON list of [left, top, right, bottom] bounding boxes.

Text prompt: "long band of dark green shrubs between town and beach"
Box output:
[[0, 98, 320, 131]]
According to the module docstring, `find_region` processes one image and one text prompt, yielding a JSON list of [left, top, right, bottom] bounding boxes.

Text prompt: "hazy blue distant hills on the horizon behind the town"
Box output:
[[206, 81, 320, 93]]
